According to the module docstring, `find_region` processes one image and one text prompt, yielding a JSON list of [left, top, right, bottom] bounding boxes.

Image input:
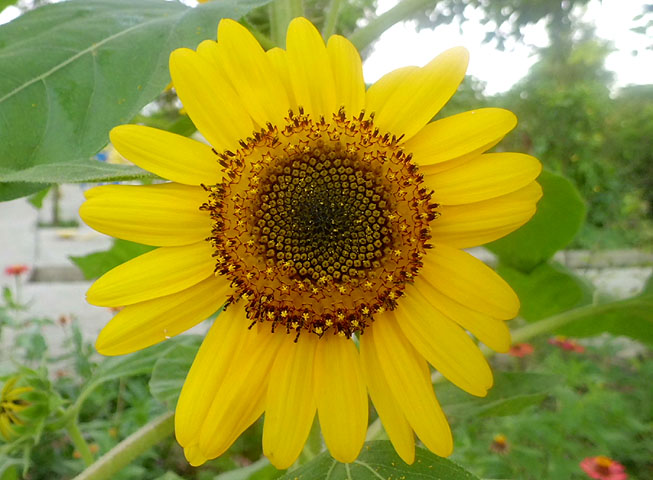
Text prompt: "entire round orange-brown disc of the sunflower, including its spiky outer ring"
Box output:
[[202, 108, 437, 336]]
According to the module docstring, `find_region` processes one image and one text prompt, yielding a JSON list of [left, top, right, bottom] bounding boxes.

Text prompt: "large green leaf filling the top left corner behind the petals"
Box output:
[[0, 0, 269, 195]]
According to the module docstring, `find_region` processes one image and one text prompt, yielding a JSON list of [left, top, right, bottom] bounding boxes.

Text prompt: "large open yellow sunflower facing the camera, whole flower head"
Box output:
[[80, 18, 541, 469]]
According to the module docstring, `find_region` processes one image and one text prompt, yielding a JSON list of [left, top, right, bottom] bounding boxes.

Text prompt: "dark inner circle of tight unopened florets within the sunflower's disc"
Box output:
[[252, 144, 393, 282]]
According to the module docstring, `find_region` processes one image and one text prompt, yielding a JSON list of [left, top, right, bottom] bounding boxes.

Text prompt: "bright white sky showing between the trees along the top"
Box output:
[[0, 0, 653, 95]]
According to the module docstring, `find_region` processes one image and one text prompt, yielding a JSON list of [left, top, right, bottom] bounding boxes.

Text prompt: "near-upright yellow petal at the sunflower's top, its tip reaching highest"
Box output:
[[286, 18, 337, 120]]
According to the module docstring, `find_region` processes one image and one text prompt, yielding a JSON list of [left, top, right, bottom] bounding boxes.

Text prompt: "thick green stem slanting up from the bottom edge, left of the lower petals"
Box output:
[[74, 412, 174, 480]]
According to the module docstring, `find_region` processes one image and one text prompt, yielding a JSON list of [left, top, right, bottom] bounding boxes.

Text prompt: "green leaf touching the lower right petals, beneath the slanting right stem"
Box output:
[[436, 372, 559, 420]]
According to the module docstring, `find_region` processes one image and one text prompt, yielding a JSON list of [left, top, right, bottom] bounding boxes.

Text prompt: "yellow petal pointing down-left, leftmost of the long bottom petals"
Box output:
[[175, 305, 251, 446]]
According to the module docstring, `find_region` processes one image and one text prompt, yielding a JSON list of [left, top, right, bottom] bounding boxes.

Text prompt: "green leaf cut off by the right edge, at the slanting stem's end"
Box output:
[[557, 280, 653, 345]]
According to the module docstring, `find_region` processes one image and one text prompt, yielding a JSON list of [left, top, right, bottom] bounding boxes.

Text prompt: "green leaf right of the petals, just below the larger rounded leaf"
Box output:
[[497, 263, 592, 321]]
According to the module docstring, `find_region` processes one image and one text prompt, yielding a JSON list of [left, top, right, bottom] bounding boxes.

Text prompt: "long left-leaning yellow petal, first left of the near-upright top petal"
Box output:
[[218, 19, 288, 127]]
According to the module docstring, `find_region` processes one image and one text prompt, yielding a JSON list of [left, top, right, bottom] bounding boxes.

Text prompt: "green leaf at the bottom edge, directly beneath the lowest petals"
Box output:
[[279, 441, 478, 480]]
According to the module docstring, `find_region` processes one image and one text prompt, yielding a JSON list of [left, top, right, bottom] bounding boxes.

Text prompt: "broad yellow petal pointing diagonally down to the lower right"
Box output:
[[396, 289, 492, 397]]
